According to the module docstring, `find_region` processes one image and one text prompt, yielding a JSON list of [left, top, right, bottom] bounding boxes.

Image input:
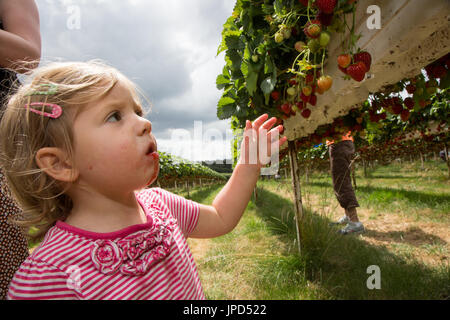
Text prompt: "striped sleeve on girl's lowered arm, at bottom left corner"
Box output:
[[7, 258, 78, 300]]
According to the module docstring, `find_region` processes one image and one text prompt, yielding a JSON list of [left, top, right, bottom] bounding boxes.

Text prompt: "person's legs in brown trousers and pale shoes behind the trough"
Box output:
[[326, 131, 364, 235]]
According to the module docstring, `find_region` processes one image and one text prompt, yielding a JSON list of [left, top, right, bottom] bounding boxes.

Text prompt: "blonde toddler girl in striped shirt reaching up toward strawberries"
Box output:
[[0, 62, 286, 299]]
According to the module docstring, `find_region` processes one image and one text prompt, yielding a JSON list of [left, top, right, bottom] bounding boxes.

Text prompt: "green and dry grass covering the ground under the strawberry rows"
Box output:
[[184, 163, 450, 300]]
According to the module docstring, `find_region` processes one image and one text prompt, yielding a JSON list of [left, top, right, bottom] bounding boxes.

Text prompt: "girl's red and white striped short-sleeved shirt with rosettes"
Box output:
[[7, 188, 205, 300]]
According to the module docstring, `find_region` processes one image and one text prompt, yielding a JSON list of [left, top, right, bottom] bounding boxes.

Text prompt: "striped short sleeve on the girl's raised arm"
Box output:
[[152, 188, 200, 236]]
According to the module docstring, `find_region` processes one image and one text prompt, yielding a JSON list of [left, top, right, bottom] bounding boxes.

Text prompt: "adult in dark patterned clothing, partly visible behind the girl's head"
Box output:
[[0, 0, 41, 300]]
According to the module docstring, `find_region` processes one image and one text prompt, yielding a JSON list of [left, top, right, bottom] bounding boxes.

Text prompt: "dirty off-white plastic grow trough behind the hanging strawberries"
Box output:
[[284, 0, 450, 141]]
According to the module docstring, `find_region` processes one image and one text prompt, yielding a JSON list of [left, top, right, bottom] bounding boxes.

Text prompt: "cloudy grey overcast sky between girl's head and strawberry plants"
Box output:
[[36, 0, 235, 160]]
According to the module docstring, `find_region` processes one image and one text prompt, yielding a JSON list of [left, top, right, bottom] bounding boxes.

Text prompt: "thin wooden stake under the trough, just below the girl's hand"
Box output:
[[288, 141, 303, 255]]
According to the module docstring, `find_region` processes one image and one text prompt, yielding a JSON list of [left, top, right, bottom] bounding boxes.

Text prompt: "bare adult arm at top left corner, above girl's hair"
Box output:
[[0, 0, 41, 73]]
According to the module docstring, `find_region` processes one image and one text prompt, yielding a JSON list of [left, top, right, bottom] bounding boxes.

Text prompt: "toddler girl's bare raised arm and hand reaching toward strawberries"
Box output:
[[190, 114, 287, 238]]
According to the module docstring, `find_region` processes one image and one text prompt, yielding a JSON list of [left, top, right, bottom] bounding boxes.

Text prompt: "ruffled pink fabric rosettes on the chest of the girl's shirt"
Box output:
[[91, 211, 176, 276]]
